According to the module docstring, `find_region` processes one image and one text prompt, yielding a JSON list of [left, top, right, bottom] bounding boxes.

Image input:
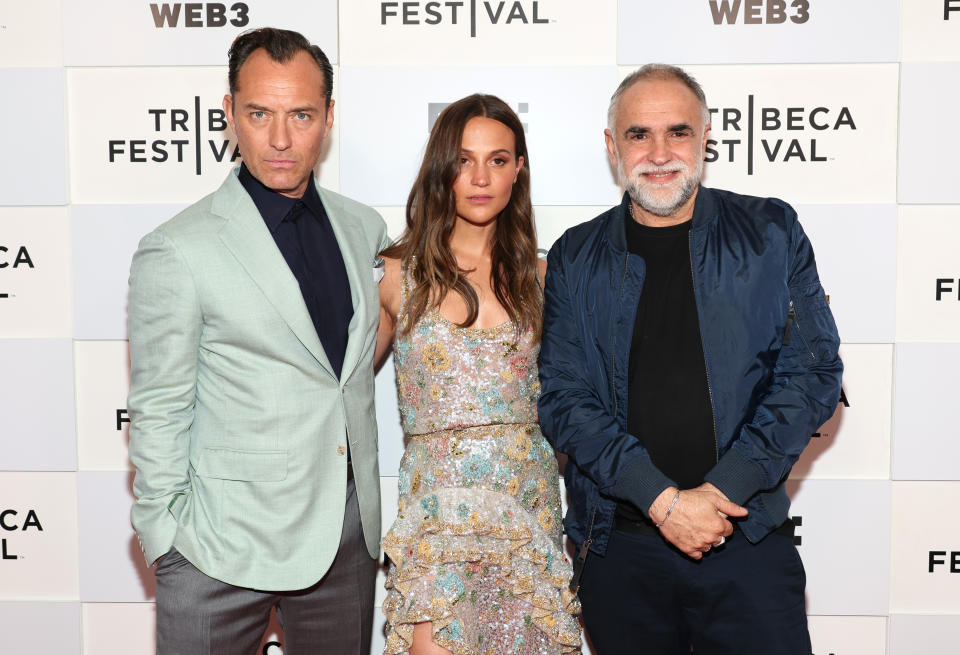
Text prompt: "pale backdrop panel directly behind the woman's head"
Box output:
[[339, 66, 620, 206]]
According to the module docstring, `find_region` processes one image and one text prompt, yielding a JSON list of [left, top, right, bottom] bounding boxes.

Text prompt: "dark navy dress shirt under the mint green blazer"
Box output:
[[240, 164, 353, 378]]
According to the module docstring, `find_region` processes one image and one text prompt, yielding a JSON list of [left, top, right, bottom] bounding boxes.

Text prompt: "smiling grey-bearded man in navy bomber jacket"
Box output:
[[539, 64, 843, 655]]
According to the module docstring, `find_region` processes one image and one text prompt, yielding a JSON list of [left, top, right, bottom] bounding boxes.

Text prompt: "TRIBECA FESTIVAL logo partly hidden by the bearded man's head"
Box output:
[[704, 93, 857, 175]]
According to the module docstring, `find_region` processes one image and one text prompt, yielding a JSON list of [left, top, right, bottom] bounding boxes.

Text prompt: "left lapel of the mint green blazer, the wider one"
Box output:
[[211, 171, 338, 378]]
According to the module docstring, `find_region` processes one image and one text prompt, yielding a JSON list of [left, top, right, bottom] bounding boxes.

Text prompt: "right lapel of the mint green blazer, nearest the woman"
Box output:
[[317, 185, 377, 382]]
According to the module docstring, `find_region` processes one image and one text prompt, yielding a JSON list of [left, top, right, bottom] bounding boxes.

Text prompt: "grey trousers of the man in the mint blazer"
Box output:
[[156, 480, 377, 655]]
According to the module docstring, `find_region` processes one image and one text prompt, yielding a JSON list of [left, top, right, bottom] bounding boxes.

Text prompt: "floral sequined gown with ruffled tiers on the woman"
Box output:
[[383, 283, 580, 655]]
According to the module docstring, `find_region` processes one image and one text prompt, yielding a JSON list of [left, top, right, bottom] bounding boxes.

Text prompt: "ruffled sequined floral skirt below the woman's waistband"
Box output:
[[383, 424, 580, 655]]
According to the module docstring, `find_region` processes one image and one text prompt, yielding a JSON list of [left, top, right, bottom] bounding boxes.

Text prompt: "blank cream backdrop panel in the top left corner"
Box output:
[[0, 0, 63, 67]]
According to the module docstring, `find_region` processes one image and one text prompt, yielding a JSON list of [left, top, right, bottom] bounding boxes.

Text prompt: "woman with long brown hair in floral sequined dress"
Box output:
[[377, 95, 580, 655]]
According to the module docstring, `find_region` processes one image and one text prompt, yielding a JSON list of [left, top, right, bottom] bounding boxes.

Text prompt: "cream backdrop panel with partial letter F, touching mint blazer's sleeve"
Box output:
[[74, 341, 133, 471]]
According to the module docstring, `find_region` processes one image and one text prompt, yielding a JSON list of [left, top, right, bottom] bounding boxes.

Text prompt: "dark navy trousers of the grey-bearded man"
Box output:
[[580, 530, 811, 655]]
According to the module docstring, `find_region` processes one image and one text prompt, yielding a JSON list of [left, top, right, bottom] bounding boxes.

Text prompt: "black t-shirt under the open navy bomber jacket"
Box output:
[[617, 212, 717, 522]]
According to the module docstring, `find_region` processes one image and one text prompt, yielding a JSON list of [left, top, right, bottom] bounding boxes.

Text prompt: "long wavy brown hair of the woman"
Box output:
[[384, 94, 543, 340]]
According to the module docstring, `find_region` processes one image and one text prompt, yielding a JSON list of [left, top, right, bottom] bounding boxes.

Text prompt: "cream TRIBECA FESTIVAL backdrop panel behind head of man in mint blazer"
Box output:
[[68, 67, 339, 204]]
